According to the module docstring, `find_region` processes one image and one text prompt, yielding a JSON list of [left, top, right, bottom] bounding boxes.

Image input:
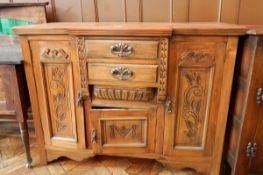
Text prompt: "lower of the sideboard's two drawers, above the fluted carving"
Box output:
[[88, 63, 158, 83]]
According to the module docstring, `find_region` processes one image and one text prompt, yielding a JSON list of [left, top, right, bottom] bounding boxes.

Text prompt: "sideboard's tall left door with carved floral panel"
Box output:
[[30, 38, 85, 149]]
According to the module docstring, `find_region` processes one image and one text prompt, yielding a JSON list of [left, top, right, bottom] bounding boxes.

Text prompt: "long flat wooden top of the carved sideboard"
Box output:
[[13, 23, 247, 36]]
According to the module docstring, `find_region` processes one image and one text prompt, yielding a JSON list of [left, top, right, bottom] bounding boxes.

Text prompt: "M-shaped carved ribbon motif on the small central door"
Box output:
[[110, 125, 137, 139]]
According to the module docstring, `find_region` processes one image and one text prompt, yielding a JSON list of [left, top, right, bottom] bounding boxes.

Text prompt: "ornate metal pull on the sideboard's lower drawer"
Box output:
[[111, 67, 133, 80]]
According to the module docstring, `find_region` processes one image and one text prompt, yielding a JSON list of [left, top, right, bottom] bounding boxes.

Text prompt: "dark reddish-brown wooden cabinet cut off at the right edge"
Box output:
[[226, 27, 263, 175]]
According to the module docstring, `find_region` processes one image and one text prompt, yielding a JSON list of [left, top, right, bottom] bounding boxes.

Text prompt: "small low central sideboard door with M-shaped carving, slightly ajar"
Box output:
[[90, 109, 156, 154]]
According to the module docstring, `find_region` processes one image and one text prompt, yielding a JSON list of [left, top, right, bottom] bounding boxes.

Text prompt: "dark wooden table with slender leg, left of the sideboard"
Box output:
[[0, 35, 32, 167]]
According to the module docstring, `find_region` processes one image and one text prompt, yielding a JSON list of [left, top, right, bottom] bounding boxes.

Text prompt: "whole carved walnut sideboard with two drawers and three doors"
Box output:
[[14, 23, 248, 174]]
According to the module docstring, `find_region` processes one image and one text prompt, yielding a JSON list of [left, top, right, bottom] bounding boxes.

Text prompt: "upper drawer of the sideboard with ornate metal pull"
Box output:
[[85, 40, 159, 59]]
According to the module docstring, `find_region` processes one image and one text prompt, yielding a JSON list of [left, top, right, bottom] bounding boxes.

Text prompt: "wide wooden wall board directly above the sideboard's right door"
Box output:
[[189, 0, 220, 22]]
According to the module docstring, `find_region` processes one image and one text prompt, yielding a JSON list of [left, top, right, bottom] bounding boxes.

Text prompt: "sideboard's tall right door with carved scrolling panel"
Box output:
[[164, 36, 227, 157]]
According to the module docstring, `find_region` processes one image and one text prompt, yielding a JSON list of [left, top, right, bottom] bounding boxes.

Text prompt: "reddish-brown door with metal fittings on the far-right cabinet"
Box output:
[[246, 36, 263, 174]]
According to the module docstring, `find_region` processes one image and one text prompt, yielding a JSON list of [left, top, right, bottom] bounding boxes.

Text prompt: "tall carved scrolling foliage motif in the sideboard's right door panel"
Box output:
[[183, 72, 204, 139]]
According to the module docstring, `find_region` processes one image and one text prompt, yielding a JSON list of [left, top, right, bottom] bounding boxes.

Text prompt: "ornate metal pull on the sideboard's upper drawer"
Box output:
[[111, 43, 133, 57]]
